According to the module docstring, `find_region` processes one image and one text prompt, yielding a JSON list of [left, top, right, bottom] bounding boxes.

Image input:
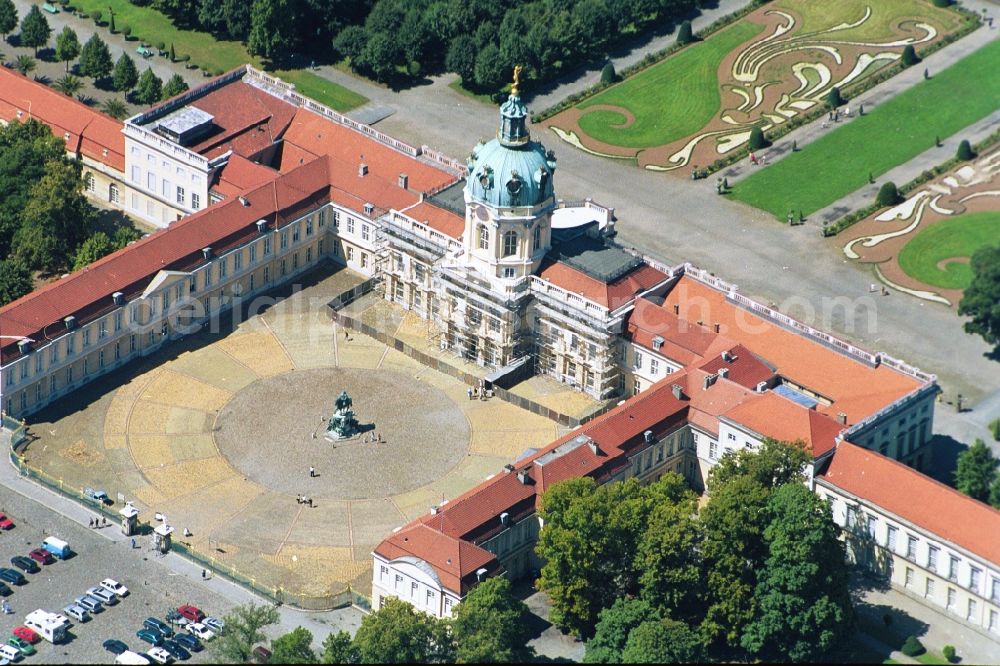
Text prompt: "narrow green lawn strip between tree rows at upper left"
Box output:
[[68, 0, 368, 111]]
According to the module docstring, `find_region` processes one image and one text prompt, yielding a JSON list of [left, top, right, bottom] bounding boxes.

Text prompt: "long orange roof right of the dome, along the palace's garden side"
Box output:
[[661, 276, 922, 423]]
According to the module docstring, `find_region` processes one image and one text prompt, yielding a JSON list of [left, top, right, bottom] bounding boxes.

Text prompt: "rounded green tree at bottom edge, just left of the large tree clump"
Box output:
[[451, 576, 534, 664]]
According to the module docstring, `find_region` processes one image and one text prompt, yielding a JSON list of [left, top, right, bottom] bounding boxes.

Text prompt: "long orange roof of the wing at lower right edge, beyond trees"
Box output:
[[819, 442, 1000, 566]]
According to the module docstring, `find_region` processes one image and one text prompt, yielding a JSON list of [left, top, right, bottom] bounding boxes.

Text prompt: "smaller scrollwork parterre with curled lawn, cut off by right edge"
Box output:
[[831, 148, 1000, 306]]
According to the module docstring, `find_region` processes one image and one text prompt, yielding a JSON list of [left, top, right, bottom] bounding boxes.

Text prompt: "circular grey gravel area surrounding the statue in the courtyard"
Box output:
[[214, 368, 470, 500]]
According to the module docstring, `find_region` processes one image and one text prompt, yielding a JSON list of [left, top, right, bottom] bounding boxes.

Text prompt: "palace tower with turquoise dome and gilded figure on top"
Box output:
[[463, 66, 556, 280]]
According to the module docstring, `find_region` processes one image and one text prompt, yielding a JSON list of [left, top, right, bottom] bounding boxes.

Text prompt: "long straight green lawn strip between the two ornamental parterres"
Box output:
[[732, 41, 1000, 218]]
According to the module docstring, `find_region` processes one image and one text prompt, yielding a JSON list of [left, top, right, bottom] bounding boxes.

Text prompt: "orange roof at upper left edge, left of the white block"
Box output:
[[0, 67, 125, 172]]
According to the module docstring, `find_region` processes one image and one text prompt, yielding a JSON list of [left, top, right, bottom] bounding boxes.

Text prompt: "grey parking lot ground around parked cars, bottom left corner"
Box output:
[[0, 486, 232, 663]]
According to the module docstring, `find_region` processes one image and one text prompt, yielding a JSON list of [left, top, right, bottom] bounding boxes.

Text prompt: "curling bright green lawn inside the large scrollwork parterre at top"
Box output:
[[579, 21, 763, 148]]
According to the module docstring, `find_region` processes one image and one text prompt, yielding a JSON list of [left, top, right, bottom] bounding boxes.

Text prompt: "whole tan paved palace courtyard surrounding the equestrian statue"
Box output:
[[25, 269, 560, 603]]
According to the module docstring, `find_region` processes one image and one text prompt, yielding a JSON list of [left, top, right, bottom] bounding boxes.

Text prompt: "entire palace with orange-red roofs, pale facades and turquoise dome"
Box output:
[[0, 66, 1000, 636]]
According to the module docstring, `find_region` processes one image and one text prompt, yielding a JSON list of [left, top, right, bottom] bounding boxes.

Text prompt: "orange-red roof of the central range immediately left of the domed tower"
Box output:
[[284, 109, 458, 192]]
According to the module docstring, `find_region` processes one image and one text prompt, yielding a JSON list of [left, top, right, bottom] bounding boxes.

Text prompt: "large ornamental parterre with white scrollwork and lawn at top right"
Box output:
[[545, 0, 967, 175]]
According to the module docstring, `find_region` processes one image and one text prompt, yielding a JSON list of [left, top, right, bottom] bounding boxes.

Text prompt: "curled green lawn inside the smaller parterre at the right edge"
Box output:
[[899, 211, 1000, 289]]
